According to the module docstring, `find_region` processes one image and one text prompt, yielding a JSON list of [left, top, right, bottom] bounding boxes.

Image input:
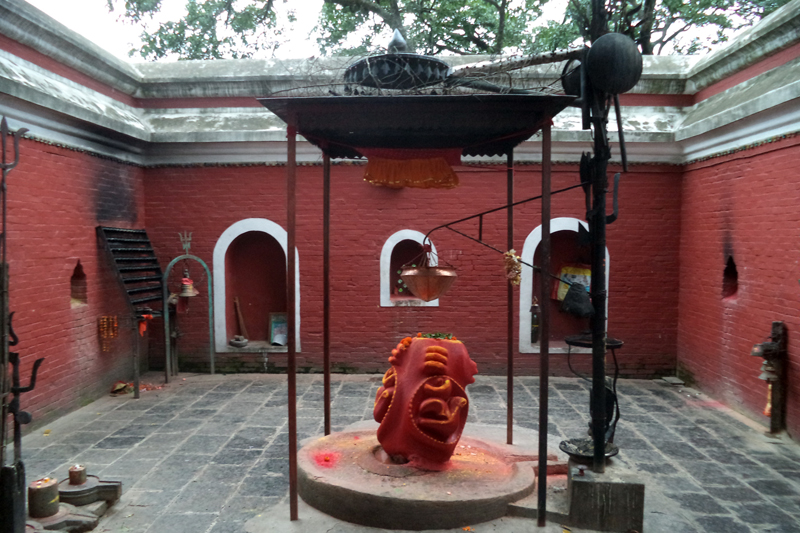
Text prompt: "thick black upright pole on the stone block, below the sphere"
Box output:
[[589, 103, 611, 474]]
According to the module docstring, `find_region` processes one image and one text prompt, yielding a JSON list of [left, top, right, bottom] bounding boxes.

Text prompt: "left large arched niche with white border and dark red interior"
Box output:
[[213, 218, 301, 353]]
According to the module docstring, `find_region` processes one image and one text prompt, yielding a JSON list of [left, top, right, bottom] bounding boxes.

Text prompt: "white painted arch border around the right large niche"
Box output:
[[519, 217, 611, 353]]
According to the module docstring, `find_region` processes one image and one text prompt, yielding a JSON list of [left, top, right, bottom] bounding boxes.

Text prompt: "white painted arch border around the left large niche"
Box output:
[[213, 218, 300, 352]]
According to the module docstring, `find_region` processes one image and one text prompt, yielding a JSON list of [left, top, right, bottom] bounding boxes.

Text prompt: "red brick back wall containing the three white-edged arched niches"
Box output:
[[145, 160, 680, 377]]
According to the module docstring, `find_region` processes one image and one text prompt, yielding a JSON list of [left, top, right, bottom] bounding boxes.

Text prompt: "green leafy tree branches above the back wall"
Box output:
[[107, 0, 789, 60]]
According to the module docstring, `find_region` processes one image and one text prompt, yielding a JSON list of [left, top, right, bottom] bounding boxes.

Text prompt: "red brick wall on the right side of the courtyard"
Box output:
[[677, 137, 800, 438]]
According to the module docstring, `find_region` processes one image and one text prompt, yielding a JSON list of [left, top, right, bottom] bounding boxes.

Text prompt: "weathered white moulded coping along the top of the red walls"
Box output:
[[0, 0, 800, 165]]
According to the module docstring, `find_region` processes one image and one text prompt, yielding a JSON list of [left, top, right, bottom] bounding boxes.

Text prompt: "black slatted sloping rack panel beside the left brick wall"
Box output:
[[97, 226, 163, 317]]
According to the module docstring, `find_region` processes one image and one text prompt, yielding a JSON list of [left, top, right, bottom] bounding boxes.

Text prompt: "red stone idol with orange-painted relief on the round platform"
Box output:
[[373, 334, 478, 468]]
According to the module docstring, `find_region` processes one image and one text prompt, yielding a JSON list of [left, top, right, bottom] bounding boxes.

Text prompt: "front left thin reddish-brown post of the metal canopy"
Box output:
[[286, 117, 298, 520]]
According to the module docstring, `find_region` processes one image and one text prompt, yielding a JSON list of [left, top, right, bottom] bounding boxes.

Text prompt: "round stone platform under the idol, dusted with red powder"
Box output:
[[298, 430, 534, 530]]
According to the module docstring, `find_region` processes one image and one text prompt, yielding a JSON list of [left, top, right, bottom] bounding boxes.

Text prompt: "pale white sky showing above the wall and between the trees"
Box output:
[[26, 0, 567, 61]]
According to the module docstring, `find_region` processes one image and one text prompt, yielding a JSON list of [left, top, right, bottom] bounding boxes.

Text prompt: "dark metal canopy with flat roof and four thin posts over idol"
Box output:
[[259, 91, 564, 524]]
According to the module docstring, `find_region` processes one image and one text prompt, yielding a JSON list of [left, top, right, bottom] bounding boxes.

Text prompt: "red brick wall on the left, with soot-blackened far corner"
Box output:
[[8, 140, 145, 423]]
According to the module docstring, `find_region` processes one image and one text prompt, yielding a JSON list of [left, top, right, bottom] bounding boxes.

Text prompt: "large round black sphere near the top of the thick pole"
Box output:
[[586, 33, 642, 94]]
